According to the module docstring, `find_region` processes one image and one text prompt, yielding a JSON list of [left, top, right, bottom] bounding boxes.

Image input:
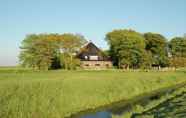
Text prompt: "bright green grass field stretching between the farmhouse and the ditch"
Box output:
[[0, 68, 186, 118]]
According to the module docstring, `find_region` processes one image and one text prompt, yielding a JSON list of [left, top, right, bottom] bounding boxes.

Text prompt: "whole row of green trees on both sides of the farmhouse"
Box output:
[[19, 29, 186, 70]]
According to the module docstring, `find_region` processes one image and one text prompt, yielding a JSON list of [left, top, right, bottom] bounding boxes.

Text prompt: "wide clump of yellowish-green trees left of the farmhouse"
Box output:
[[19, 34, 86, 70]]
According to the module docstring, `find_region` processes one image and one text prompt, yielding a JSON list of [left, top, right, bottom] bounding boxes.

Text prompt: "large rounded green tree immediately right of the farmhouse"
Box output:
[[106, 30, 145, 68]]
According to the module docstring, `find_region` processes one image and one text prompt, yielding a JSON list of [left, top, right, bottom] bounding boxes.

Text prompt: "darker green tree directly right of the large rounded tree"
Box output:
[[144, 33, 168, 67]]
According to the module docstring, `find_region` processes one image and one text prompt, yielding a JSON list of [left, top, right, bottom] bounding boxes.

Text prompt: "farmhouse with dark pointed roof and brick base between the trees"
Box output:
[[77, 42, 112, 69]]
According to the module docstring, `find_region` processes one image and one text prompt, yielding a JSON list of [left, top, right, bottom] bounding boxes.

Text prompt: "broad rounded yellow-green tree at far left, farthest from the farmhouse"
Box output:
[[19, 34, 59, 70]]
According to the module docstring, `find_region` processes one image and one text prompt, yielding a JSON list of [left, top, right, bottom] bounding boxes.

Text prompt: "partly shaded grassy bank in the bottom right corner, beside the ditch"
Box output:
[[112, 84, 186, 118]]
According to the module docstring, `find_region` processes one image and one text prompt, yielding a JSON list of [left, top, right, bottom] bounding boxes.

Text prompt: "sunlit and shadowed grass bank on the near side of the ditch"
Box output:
[[112, 83, 186, 118]]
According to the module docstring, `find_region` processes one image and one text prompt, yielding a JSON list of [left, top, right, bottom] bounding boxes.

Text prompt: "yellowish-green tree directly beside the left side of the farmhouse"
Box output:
[[60, 34, 87, 69]]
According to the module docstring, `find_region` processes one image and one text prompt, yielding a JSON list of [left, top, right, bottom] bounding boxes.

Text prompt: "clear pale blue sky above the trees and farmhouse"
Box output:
[[0, 0, 186, 66]]
